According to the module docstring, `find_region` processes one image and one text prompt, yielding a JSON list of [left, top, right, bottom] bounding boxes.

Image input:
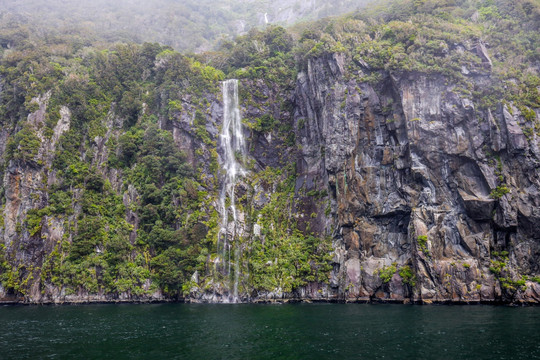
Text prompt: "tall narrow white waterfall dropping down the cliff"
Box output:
[[218, 79, 246, 302]]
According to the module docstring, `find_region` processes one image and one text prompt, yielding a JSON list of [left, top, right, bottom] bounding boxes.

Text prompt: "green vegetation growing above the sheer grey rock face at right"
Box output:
[[295, 0, 540, 113]]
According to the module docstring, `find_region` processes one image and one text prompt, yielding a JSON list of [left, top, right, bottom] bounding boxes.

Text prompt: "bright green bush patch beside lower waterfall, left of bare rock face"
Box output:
[[245, 166, 332, 292]]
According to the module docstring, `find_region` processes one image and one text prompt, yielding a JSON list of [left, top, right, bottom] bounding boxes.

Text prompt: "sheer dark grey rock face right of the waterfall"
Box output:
[[295, 54, 540, 302]]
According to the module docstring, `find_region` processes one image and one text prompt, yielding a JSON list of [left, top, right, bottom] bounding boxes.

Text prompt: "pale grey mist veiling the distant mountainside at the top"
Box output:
[[0, 0, 368, 52]]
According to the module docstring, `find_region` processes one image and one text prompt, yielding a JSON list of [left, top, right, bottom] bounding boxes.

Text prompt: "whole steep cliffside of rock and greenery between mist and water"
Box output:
[[0, 0, 540, 303]]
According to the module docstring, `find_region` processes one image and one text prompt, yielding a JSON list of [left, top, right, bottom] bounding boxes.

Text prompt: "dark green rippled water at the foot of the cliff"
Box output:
[[0, 304, 540, 359]]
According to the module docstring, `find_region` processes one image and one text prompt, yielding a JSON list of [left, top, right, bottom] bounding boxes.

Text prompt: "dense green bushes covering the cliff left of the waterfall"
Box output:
[[0, 37, 227, 296]]
